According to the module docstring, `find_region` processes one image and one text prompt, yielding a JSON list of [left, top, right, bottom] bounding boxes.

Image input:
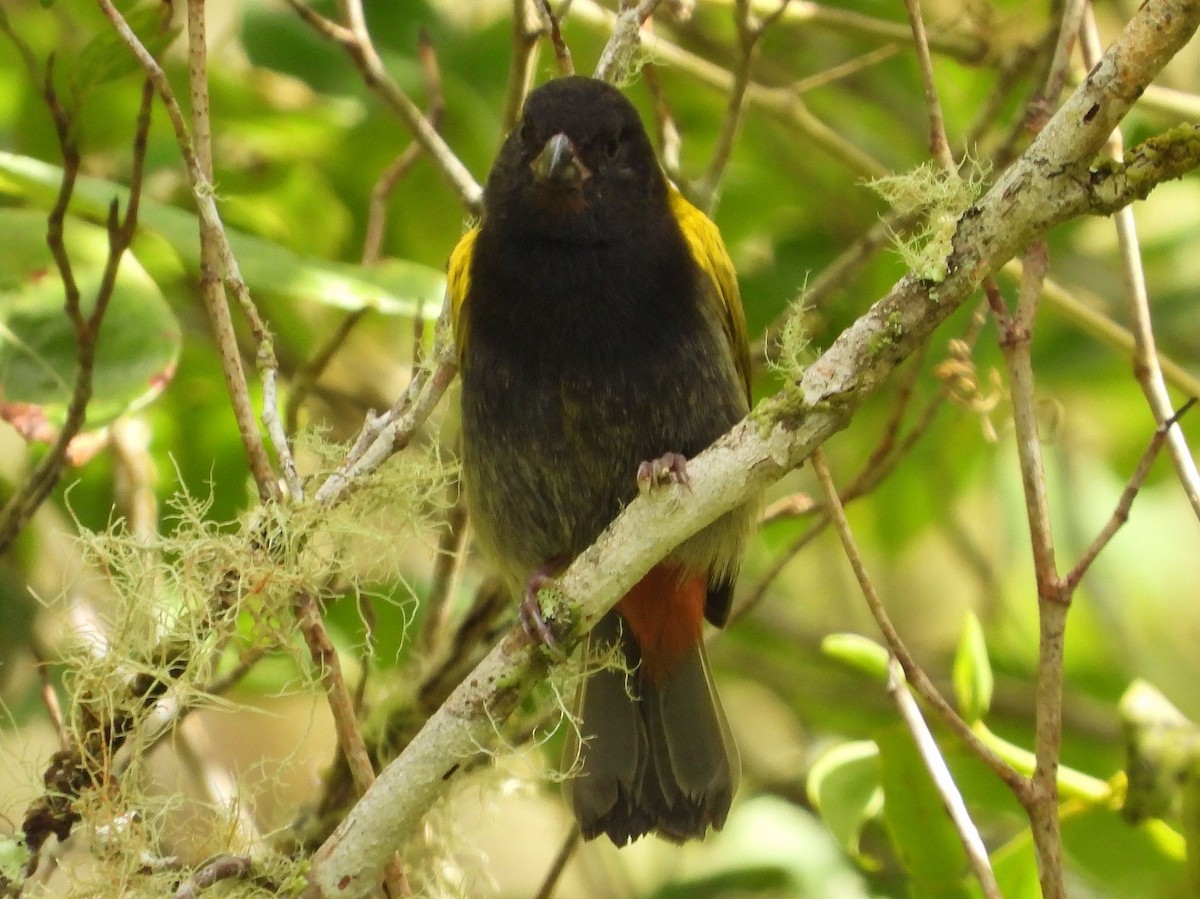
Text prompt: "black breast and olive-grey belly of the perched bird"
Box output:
[[462, 228, 744, 571]]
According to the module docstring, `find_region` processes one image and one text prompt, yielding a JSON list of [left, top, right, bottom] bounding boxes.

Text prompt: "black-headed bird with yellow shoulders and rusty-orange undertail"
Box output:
[[448, 76, 757, 846]]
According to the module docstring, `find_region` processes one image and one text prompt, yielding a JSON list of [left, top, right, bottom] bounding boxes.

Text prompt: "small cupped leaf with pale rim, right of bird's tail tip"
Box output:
[[806, 739, 883, 858]]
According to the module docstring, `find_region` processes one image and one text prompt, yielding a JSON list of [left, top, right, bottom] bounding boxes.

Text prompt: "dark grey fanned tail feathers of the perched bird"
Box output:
[[564, 611, 740, 846]]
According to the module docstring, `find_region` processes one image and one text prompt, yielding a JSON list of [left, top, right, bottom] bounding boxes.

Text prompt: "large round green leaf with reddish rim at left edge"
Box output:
[[0, 208, 180, 439]]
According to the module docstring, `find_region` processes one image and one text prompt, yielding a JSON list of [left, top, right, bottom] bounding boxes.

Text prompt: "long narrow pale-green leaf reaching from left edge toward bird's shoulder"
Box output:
[[0, 152, 445, 318]]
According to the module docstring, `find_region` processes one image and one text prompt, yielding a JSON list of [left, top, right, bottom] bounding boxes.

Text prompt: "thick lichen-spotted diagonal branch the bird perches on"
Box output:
[[306, 0, 1200, 899]]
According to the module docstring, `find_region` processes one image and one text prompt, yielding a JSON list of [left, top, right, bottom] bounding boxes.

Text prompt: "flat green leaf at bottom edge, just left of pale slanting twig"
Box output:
[[876, 724, 970, 899]]
